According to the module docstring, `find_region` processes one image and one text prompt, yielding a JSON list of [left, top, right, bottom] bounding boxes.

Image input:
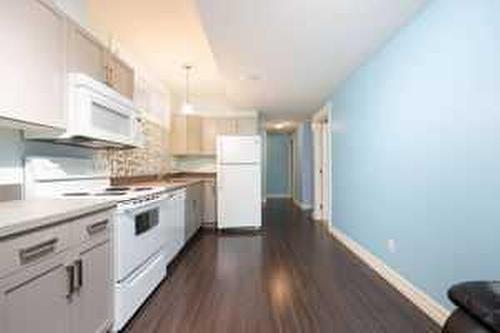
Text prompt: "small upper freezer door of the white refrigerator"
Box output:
[[217, 136, 261, 164]]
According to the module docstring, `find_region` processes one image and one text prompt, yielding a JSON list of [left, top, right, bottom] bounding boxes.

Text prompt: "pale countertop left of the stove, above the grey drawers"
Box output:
[[0, 199, 116, 239]]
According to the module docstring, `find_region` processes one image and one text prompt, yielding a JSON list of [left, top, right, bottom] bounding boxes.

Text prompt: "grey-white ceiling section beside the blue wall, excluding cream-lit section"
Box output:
[[197, 0, 426, 119]]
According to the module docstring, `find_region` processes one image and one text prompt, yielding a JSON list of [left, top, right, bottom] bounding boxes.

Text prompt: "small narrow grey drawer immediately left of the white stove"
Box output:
[[73, 210, 113, 244]]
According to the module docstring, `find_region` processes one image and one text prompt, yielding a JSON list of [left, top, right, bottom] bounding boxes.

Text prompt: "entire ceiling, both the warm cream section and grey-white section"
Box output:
[[89, 0, 427, 119]]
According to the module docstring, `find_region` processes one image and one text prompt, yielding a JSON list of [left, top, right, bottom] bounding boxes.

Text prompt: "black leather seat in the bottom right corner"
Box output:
[[442, 281, 500, 333]]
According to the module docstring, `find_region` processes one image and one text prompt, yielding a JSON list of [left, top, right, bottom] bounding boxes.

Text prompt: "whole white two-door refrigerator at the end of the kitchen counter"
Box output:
[[217, 135, 262, 229]]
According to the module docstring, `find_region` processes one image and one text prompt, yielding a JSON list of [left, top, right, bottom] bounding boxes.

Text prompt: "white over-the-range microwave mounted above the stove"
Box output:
[[27, 73, 142, 148]]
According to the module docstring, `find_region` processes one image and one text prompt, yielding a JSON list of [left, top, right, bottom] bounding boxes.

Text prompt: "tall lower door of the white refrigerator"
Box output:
[[217, 164, 262, 229]]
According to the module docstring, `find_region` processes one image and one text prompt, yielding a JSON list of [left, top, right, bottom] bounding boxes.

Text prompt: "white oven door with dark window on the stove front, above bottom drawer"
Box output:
[[114, 197, 166, 282]]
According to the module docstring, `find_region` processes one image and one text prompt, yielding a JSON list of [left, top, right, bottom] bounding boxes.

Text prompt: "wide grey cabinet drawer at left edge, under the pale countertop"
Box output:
[[0, 223, 72, 278]]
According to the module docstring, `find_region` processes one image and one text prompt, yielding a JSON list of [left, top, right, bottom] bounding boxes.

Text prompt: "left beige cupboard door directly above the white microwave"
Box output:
[[68, 22, 107, 83]]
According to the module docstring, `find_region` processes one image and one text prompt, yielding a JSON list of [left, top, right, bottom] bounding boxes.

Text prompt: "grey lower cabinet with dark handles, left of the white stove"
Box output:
[[0, 212, 113, 333]]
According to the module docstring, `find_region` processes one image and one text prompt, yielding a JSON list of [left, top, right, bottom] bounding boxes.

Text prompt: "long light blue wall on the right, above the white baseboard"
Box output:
[[330, 0, 500, 307]]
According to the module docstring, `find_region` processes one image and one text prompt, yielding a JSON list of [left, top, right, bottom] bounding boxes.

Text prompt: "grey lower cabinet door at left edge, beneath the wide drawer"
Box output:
[[0, 256, 73, 333]]
